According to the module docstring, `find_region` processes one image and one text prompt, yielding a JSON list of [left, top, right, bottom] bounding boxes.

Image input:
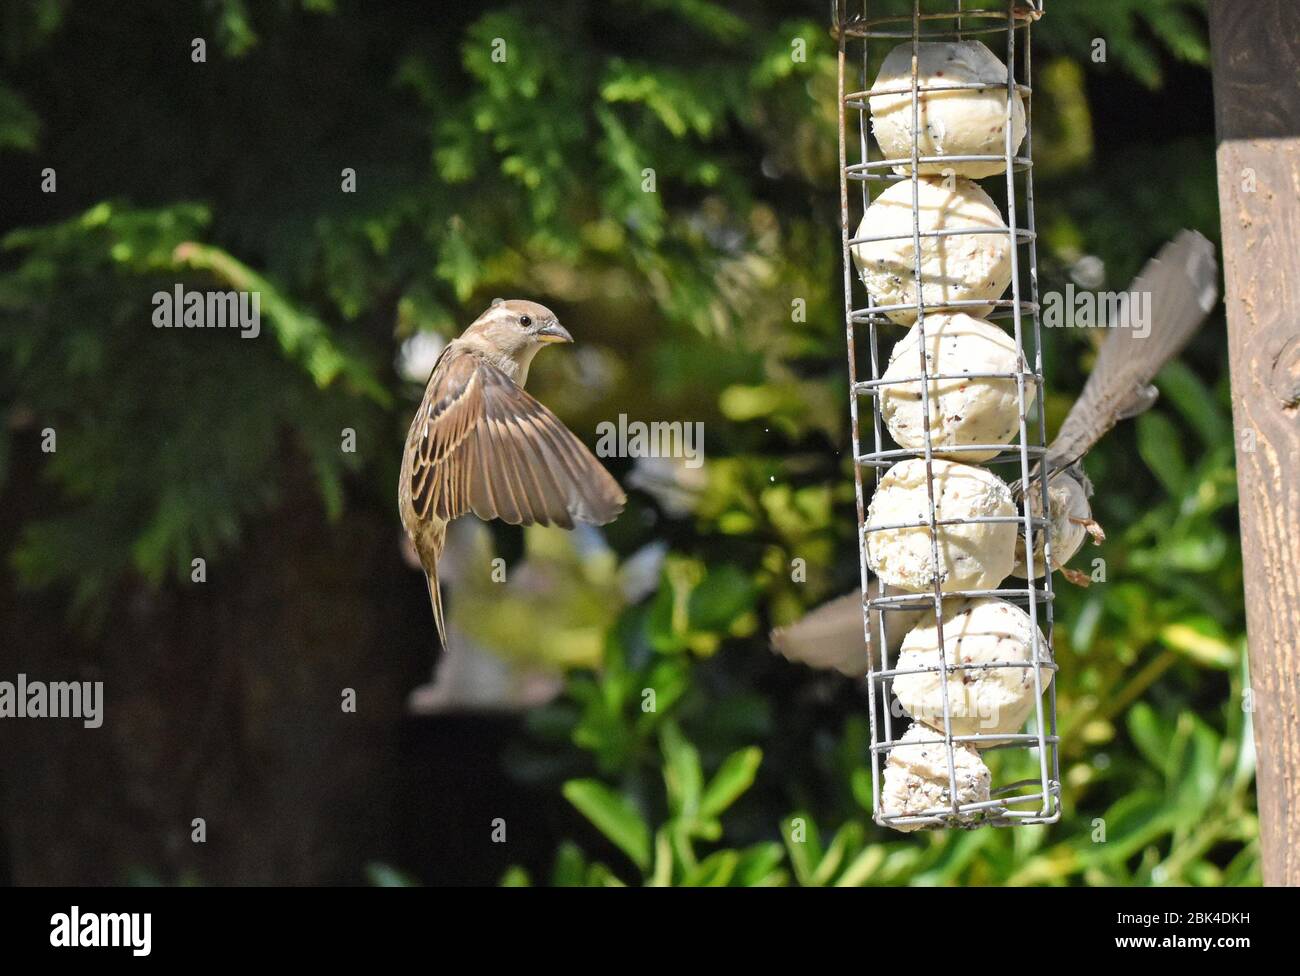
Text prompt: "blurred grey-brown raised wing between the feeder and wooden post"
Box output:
[[1048, 230, 1218, 473]]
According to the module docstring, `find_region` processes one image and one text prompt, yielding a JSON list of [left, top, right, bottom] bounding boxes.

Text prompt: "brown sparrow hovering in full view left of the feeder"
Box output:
[[398, 299, 627, 647]]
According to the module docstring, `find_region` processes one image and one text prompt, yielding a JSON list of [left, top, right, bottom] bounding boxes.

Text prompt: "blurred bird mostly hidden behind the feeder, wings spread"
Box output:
[[772, 230, 1218, 677]]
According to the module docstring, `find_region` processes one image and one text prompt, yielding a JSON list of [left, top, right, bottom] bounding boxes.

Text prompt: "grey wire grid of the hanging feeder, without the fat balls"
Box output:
[[832, 0, 1061, 829]]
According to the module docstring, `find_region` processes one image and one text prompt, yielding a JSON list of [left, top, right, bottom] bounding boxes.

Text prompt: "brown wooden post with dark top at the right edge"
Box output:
[[1210, 0, 1300, 885]]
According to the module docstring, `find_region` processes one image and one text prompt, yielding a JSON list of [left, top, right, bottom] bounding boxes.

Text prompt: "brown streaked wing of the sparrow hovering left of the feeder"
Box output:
[[406, 351, 627, 529]]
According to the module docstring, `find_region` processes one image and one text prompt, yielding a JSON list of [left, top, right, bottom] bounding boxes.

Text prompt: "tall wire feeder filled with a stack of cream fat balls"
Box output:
[[833, 0, 1061, 830]]
